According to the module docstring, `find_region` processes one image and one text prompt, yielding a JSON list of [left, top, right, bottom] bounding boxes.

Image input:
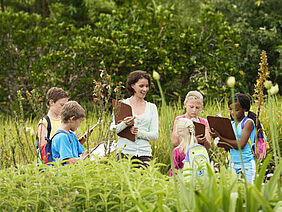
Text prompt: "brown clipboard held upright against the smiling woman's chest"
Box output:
[[112, 99, 135, 142]]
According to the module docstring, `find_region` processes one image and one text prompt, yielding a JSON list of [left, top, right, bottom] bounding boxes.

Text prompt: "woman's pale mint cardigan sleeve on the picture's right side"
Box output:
[[136, 104, 159, 141]]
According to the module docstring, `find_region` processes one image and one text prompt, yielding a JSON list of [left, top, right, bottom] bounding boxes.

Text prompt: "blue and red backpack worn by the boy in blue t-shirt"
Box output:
[[40, 130, 71, 164]]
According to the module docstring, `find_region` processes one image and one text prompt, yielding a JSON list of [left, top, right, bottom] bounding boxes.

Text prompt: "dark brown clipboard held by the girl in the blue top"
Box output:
[[207, 116, 236, 140]]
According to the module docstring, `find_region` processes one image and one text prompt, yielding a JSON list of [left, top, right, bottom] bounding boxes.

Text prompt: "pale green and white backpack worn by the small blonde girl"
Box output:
[[182, 144, 210, 177]]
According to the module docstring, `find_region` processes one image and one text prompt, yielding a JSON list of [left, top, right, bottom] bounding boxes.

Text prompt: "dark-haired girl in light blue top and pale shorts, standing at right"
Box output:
[[211, 93, 261, 184]]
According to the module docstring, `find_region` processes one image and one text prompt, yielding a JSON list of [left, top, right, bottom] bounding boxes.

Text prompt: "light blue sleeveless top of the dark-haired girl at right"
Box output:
[[230, 118, 255, 163]]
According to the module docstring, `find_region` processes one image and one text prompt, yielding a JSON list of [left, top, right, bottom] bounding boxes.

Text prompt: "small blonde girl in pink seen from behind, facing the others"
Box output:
[[170, 118, 198, 176]]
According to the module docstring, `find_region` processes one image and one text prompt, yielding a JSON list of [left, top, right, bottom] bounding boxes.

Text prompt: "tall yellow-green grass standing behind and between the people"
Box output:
[[0, 97, 282, 171]]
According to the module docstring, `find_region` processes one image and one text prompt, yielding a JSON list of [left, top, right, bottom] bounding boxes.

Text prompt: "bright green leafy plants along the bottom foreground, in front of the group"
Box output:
[[0, 159, 281, 212]]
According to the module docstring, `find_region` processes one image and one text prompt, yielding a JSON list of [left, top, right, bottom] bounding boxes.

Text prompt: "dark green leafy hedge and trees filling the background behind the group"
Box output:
[[0, 0, 281, 112]]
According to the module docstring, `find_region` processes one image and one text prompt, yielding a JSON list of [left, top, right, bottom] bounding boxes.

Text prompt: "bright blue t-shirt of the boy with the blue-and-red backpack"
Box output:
[[52, 130, 84, 161]]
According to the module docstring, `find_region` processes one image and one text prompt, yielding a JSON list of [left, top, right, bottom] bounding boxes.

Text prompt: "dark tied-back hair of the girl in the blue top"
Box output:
[[228, 93, 262, 129]]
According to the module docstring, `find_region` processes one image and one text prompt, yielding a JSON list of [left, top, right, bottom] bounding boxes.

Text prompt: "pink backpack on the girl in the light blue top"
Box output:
[[241, 117, 269, 159]]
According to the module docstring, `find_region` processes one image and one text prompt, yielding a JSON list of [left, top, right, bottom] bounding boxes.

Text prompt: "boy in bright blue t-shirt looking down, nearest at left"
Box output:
[[51, 101, 85, 164]]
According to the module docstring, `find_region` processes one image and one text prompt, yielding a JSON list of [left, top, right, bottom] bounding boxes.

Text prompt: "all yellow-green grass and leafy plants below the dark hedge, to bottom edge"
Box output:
[[0, 98, 282, 211]]
